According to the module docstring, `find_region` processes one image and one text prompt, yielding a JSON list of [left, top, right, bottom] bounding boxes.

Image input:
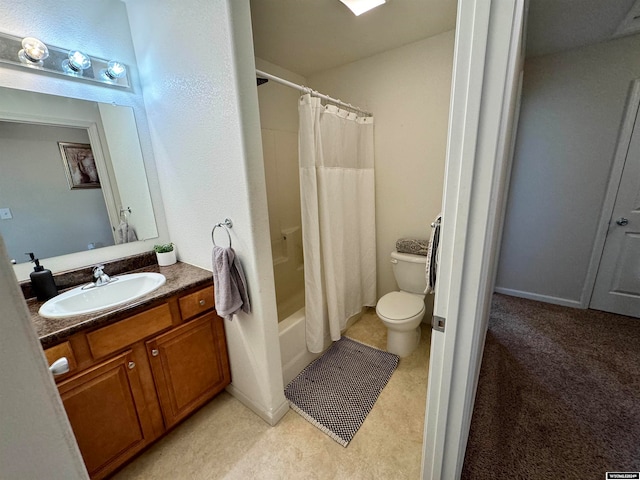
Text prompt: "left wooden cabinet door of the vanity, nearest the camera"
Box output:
[[58, 350, 149, 478]]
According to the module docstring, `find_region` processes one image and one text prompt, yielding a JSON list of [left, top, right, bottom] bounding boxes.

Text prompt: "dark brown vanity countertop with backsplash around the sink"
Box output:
[[28, 258, 213, 349]]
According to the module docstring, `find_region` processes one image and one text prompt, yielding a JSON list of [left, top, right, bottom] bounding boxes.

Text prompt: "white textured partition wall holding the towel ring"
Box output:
[[127, 0, 288, 421]]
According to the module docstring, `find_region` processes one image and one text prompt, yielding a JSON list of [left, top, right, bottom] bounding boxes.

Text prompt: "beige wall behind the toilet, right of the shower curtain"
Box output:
[[309, 31, 454, 308]]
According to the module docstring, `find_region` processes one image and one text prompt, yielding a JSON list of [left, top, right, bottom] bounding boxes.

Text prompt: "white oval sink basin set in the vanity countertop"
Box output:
[[38, 272, 166, 318]]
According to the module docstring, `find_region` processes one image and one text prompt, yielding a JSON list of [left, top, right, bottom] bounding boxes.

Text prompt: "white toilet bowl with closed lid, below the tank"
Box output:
[[376, 291, 425, 357]]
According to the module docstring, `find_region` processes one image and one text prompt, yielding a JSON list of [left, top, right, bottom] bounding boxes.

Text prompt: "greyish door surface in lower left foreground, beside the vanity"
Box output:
[[0, 235, 89, 480]]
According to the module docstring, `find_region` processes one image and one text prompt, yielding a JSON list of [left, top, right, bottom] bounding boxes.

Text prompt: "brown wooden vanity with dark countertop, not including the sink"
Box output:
[[28, 263, 231, 479]]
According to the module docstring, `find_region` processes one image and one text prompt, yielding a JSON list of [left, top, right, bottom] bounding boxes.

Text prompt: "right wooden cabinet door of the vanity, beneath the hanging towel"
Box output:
[[147, 312, 231, 428]]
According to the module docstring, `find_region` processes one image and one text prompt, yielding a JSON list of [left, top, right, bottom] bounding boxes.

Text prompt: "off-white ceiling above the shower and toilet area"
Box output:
[[251, 0, 456, 76]]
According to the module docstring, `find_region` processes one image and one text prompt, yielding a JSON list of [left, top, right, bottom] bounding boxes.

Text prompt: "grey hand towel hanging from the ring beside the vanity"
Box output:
[[212, 246, 251, 319]]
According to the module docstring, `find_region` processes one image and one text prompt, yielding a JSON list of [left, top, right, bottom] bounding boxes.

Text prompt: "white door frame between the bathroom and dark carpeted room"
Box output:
[[421, 0, 525, 480]]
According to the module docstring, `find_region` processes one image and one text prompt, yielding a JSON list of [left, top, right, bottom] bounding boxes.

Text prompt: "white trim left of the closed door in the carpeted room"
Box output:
[[580, 78, 640, 308]]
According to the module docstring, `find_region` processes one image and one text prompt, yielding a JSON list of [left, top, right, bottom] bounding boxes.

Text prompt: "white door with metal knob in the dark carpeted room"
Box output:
[[589, 96, 640, 317]]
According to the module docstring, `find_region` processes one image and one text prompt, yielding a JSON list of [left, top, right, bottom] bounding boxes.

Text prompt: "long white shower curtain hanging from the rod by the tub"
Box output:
[[298, 94, 376, 353]]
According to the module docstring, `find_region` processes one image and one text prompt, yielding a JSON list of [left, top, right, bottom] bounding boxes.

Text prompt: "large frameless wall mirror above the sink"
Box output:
[[0, 88, 158, 263]]
